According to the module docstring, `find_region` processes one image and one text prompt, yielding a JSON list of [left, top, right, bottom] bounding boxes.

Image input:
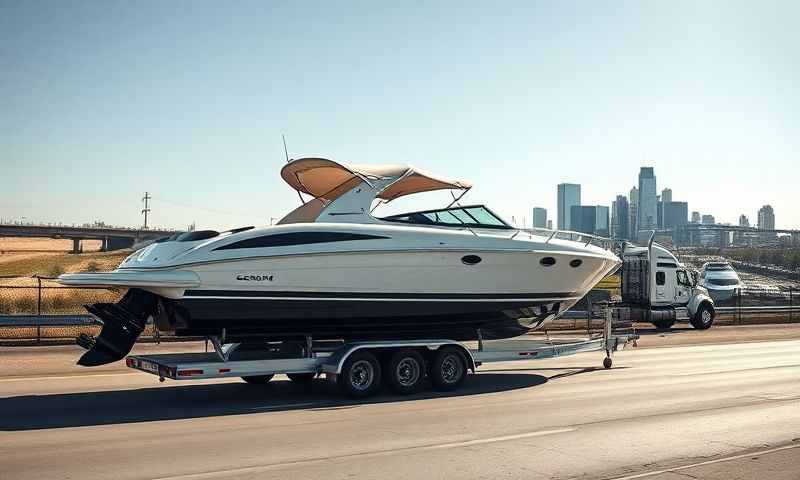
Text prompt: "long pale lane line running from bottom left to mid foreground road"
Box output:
[[152, 428, 577, 480]]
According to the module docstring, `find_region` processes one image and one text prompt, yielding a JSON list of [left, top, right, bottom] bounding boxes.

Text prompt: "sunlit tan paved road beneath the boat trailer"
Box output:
[[0, 325, 800, 480]]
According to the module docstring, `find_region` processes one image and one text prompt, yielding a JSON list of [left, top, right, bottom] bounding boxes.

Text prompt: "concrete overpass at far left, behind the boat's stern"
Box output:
[[0, 225, 176, 253]]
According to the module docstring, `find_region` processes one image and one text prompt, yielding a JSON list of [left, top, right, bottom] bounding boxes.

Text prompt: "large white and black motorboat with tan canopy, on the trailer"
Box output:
[[59, 158, 621, 366]]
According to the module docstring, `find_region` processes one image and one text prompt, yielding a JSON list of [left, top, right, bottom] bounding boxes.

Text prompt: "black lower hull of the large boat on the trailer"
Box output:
[[175, 298, 566, 341]]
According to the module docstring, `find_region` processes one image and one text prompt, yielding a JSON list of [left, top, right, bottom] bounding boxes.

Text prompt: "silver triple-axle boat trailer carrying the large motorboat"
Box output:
[[125, 304, 639, 398]]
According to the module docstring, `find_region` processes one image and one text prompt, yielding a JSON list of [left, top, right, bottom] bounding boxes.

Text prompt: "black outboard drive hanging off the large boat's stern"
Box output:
[[75, 288, 160, 367]]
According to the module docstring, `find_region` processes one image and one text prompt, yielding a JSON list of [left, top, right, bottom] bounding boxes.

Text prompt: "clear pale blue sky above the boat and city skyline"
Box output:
[[0, 0, 800, 229]]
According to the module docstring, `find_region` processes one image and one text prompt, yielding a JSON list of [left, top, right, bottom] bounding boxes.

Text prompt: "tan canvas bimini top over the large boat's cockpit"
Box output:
[[281, 158, 472, 202]]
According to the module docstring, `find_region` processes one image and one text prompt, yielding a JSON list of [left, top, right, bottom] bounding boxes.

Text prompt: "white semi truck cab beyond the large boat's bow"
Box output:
[[621, 238, 716, 330]]
